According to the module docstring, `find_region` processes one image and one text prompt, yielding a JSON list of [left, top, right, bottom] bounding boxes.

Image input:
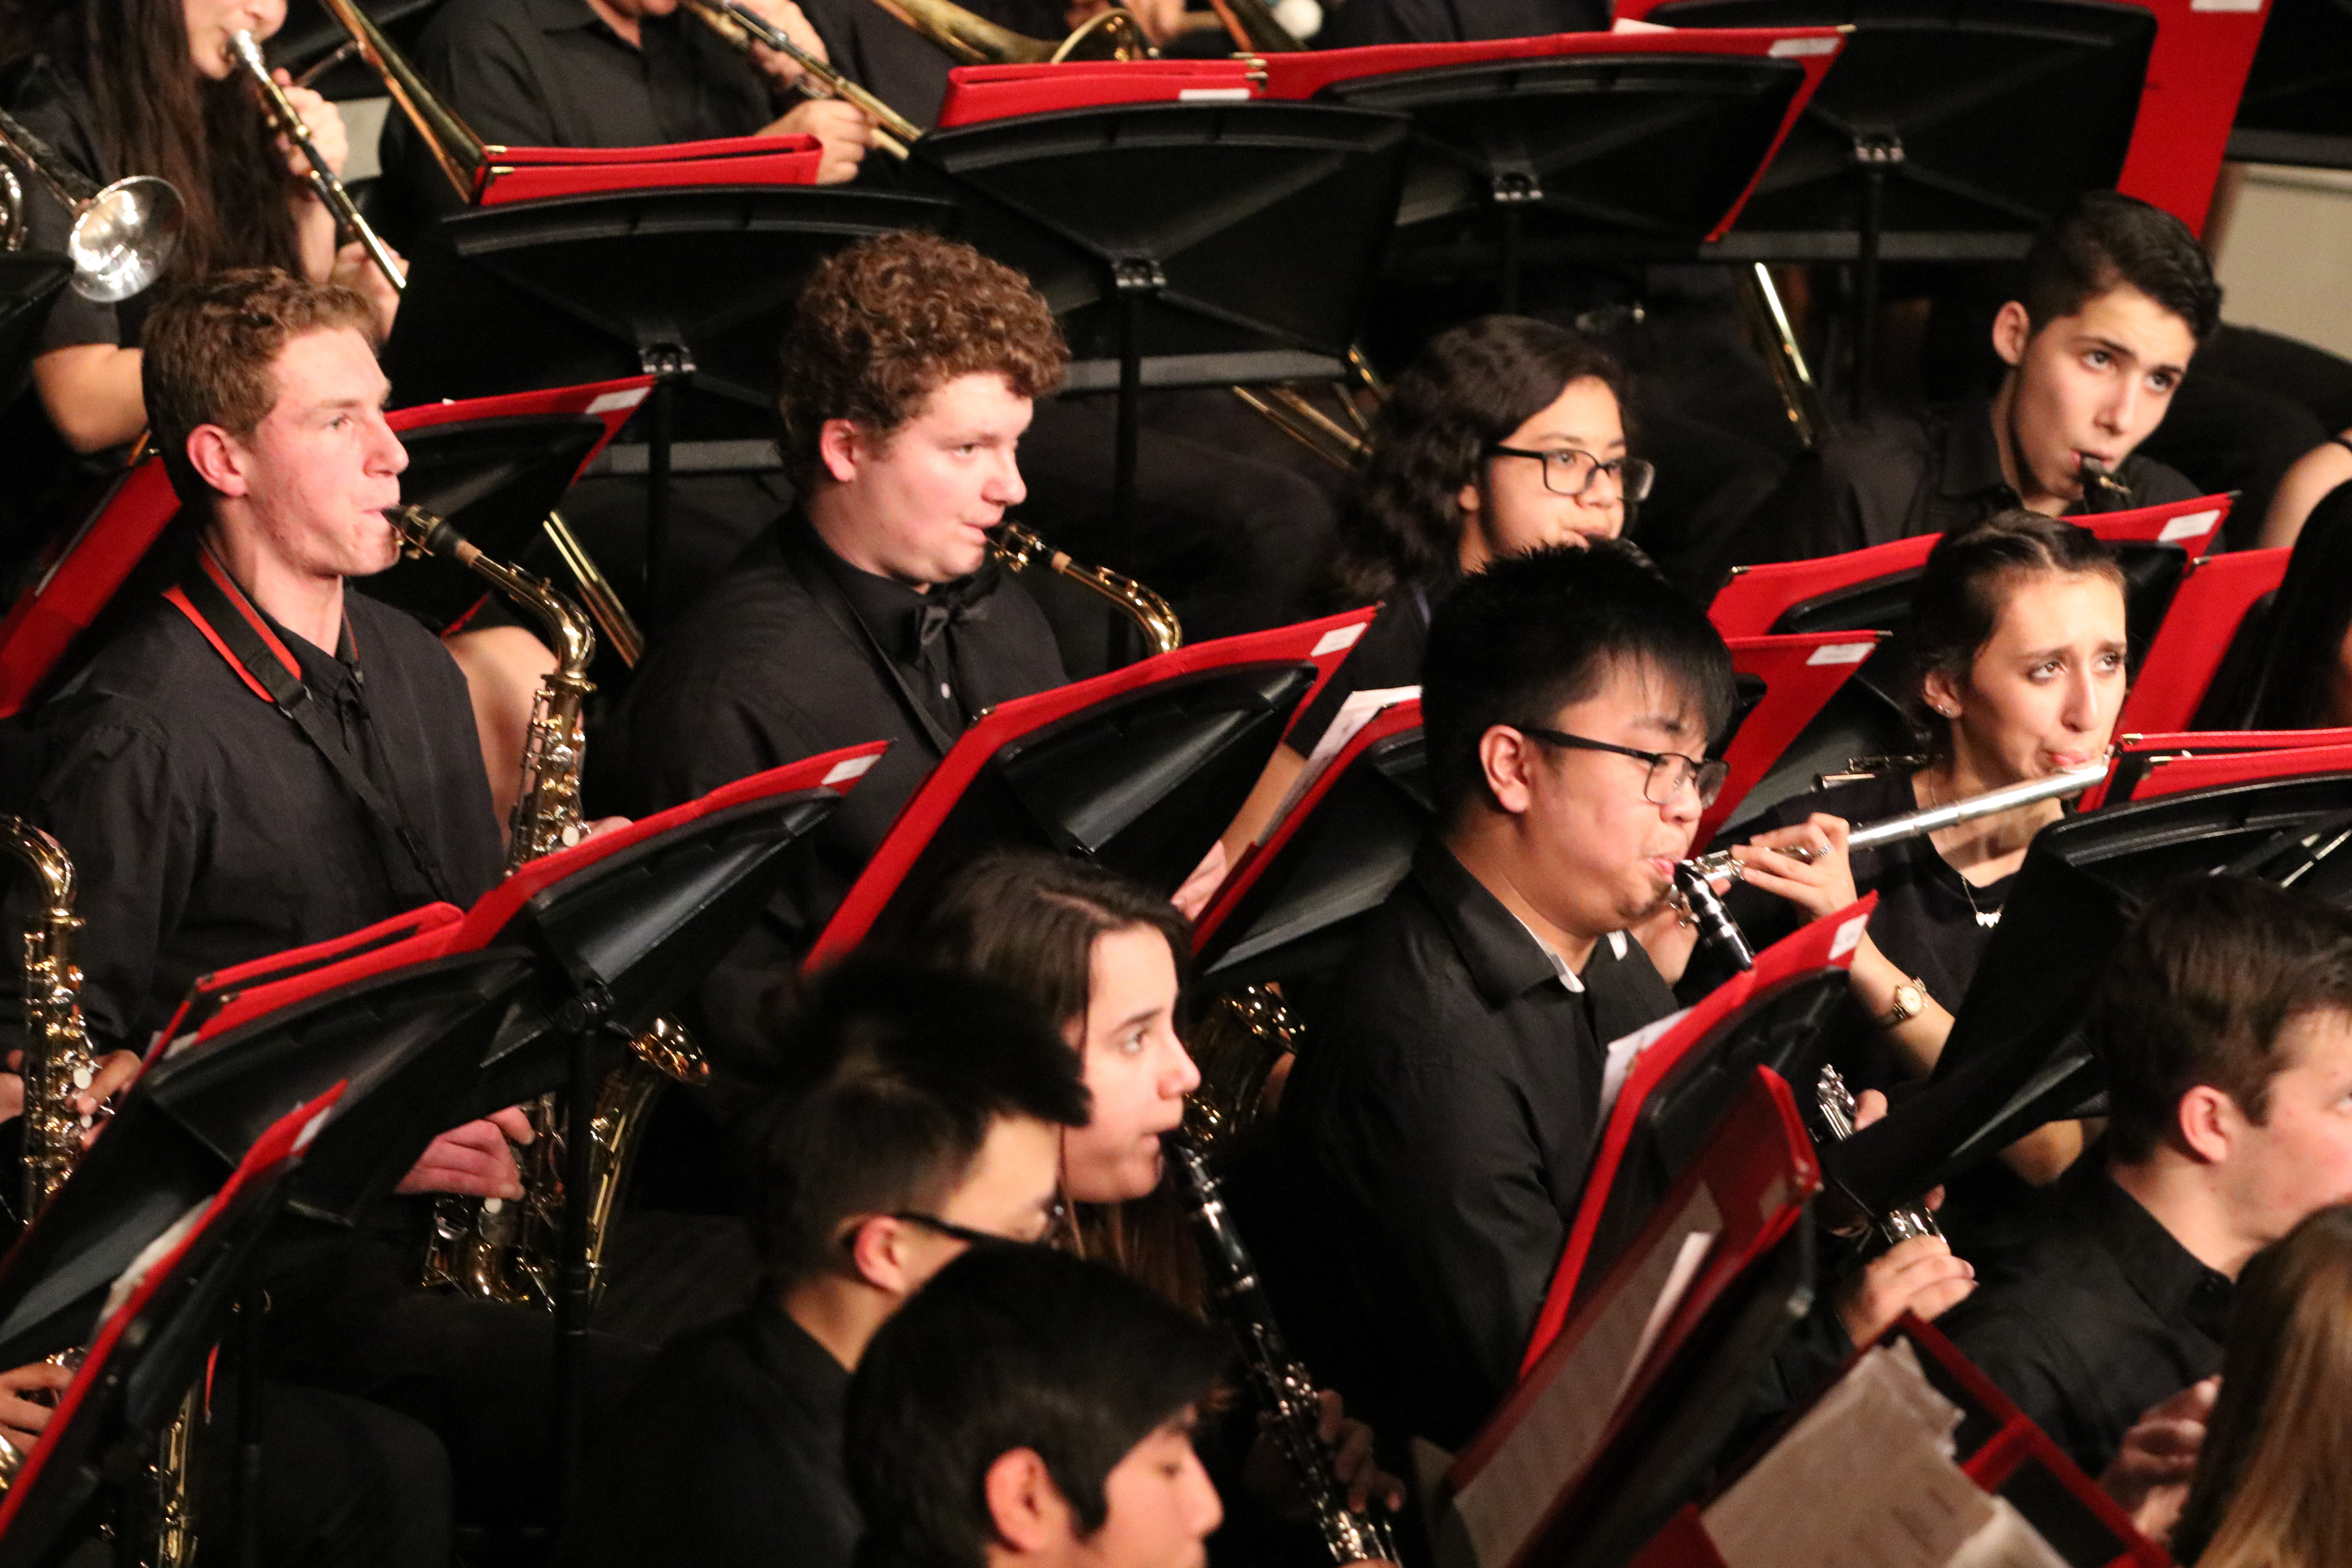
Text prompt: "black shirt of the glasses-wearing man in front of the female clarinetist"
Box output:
[[562, 1302, 863, 1568]]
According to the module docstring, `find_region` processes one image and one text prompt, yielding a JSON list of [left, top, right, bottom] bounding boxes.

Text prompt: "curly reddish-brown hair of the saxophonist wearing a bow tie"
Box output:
[[776, 230, 1070, 496]]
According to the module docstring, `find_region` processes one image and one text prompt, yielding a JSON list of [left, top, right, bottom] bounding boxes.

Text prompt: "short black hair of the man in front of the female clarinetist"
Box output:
[[743, 957, 1091, 1286]]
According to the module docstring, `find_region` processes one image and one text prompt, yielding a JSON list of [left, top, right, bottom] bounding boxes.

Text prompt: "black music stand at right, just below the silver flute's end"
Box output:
[[1823, 773, 2352, 1213]]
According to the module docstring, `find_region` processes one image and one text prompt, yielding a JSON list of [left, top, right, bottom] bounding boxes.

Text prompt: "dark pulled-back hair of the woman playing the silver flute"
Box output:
[[1905, 508, 2126, 755]]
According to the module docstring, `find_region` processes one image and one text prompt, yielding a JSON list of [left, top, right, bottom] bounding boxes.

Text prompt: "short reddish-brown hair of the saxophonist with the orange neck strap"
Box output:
[[139, 268, 376, 503]]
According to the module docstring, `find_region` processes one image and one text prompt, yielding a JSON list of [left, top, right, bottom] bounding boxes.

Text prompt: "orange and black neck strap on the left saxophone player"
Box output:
[[162, 550, 461, 907]]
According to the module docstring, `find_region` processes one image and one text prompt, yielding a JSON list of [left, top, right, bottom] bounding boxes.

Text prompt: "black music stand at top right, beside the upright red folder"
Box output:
[[1646, 0, 2157, 414]]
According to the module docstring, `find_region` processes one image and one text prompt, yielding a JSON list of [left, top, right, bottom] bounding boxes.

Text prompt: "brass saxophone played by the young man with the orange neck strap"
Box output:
[[386, 505, 710, 1309]]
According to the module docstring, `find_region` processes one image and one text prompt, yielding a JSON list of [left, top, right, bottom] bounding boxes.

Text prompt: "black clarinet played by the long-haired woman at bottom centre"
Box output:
[[1169, 1138, 1404, 1563]]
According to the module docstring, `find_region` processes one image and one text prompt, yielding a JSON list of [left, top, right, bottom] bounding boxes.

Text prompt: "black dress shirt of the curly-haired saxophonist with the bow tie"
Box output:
[[588, 512, 1065, 1081]]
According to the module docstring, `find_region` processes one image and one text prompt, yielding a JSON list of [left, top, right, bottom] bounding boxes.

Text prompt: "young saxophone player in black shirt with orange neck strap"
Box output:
[[0, 268, 642, 1521]]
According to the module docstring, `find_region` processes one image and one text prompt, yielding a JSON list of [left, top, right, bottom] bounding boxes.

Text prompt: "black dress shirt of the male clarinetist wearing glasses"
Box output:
[[1282, 839, 1675, 1448]]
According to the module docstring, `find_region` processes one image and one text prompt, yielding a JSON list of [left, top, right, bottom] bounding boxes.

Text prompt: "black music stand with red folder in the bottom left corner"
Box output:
[[0, 1086, 341, 1568]]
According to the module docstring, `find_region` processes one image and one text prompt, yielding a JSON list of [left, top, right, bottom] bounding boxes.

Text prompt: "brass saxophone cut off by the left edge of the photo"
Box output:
[[0, 816, 202, 1568]]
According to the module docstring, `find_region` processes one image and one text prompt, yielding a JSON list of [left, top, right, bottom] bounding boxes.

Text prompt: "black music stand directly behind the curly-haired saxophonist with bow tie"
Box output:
[[908, 103, 1406, 566]]
